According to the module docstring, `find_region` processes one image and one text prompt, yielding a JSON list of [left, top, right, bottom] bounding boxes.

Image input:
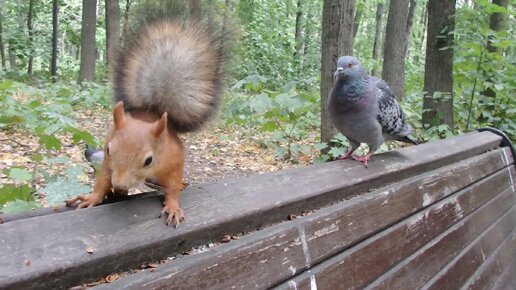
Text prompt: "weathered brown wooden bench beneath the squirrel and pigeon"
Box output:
[[0, 132, 516, 289]]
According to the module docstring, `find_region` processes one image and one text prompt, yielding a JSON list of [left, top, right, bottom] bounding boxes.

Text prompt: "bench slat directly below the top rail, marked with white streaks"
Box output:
[[98, 150, 509, 289]]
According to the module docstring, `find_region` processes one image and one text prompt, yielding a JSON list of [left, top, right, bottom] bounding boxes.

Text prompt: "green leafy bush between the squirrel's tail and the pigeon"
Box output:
[[223, 75, 320, 160]]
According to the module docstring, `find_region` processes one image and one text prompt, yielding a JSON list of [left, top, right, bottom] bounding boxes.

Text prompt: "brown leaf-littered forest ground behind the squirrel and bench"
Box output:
[[0, 109, 318, 206]]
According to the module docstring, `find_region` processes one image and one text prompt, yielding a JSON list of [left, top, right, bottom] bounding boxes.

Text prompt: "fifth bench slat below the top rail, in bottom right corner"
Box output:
[[461, 231, 516, 289]]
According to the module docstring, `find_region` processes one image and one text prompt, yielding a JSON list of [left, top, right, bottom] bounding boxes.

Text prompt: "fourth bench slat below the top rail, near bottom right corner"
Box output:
[[422, 206, 516, 290]]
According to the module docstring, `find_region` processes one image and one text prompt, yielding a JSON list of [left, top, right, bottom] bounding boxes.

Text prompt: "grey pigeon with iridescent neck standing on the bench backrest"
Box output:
[[327, 56, 418, 167]]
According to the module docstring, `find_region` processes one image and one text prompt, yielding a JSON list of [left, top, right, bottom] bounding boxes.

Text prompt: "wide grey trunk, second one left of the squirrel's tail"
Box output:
[[79, 0, 97, 82]]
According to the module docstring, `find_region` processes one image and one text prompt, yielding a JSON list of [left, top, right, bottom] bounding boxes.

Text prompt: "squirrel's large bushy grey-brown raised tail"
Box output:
[[113, 20, 224, 132]]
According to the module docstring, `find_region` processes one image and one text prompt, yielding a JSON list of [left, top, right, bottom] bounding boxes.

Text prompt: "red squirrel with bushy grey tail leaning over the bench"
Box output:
[[66, 21, 224, 227]]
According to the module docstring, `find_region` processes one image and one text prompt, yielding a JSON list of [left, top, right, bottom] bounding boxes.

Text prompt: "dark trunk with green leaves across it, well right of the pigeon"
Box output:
[[423, 0, 455, 129]]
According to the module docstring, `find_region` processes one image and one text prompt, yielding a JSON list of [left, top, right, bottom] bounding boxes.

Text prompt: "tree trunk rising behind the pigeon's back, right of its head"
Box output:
[[382, 0, 409, 100]]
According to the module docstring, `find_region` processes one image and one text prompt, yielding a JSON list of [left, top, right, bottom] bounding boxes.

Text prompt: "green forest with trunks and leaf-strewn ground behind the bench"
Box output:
[[0, 0, 516, 213]]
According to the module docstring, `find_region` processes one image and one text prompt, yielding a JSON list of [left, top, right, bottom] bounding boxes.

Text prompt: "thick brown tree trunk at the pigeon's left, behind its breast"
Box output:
[[321, 0, 355, 142]]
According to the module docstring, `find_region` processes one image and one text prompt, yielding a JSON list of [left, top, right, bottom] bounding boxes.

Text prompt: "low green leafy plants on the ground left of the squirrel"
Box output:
[[0, 79, 109, 213]]
